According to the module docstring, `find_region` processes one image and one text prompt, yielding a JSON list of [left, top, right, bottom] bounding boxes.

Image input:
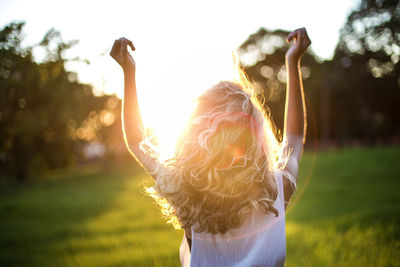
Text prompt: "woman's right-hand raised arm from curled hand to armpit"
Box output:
[[283, 28, 311, 206]]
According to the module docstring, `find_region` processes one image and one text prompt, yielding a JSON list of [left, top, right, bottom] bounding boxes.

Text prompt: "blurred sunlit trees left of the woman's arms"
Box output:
[[0, 23, 128, 180]]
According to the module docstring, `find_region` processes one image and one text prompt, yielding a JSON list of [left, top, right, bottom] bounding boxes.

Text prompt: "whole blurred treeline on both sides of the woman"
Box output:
[[0, 0, 400, 180]]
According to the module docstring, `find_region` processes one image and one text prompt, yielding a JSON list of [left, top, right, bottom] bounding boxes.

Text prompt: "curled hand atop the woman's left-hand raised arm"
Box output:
[[110, 37, 136, 72]]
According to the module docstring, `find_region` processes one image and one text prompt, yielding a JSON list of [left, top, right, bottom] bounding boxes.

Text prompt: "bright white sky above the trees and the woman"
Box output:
[[0, 0, 359, 154]]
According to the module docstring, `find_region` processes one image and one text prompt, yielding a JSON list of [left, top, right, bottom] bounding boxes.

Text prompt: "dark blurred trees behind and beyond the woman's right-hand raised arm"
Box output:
[[239, 0, 400, 145]]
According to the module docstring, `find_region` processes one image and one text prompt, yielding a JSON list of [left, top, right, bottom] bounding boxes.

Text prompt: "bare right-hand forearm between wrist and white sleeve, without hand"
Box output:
[[283, 59, 306, 141]]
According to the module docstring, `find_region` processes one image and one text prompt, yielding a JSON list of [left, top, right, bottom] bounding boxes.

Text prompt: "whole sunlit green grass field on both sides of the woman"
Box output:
[[0, 147, 400, 266]]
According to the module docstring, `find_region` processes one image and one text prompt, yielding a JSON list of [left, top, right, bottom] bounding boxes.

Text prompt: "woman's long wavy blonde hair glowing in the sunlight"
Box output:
[[146, 76, 285, 233]]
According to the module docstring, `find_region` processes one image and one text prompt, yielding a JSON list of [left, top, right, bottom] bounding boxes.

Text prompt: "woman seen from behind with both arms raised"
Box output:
[[110, 28, 311, 266]]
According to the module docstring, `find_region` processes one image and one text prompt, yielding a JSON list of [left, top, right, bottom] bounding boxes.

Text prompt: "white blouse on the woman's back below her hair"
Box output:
[[180, 171, 286, 267]]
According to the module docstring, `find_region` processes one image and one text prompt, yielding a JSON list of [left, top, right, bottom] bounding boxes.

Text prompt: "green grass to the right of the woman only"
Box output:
[[286, 148, 400, 266]]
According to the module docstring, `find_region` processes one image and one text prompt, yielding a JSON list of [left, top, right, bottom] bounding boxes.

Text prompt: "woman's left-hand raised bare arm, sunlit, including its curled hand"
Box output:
[[110, 38, 158, 177]]
